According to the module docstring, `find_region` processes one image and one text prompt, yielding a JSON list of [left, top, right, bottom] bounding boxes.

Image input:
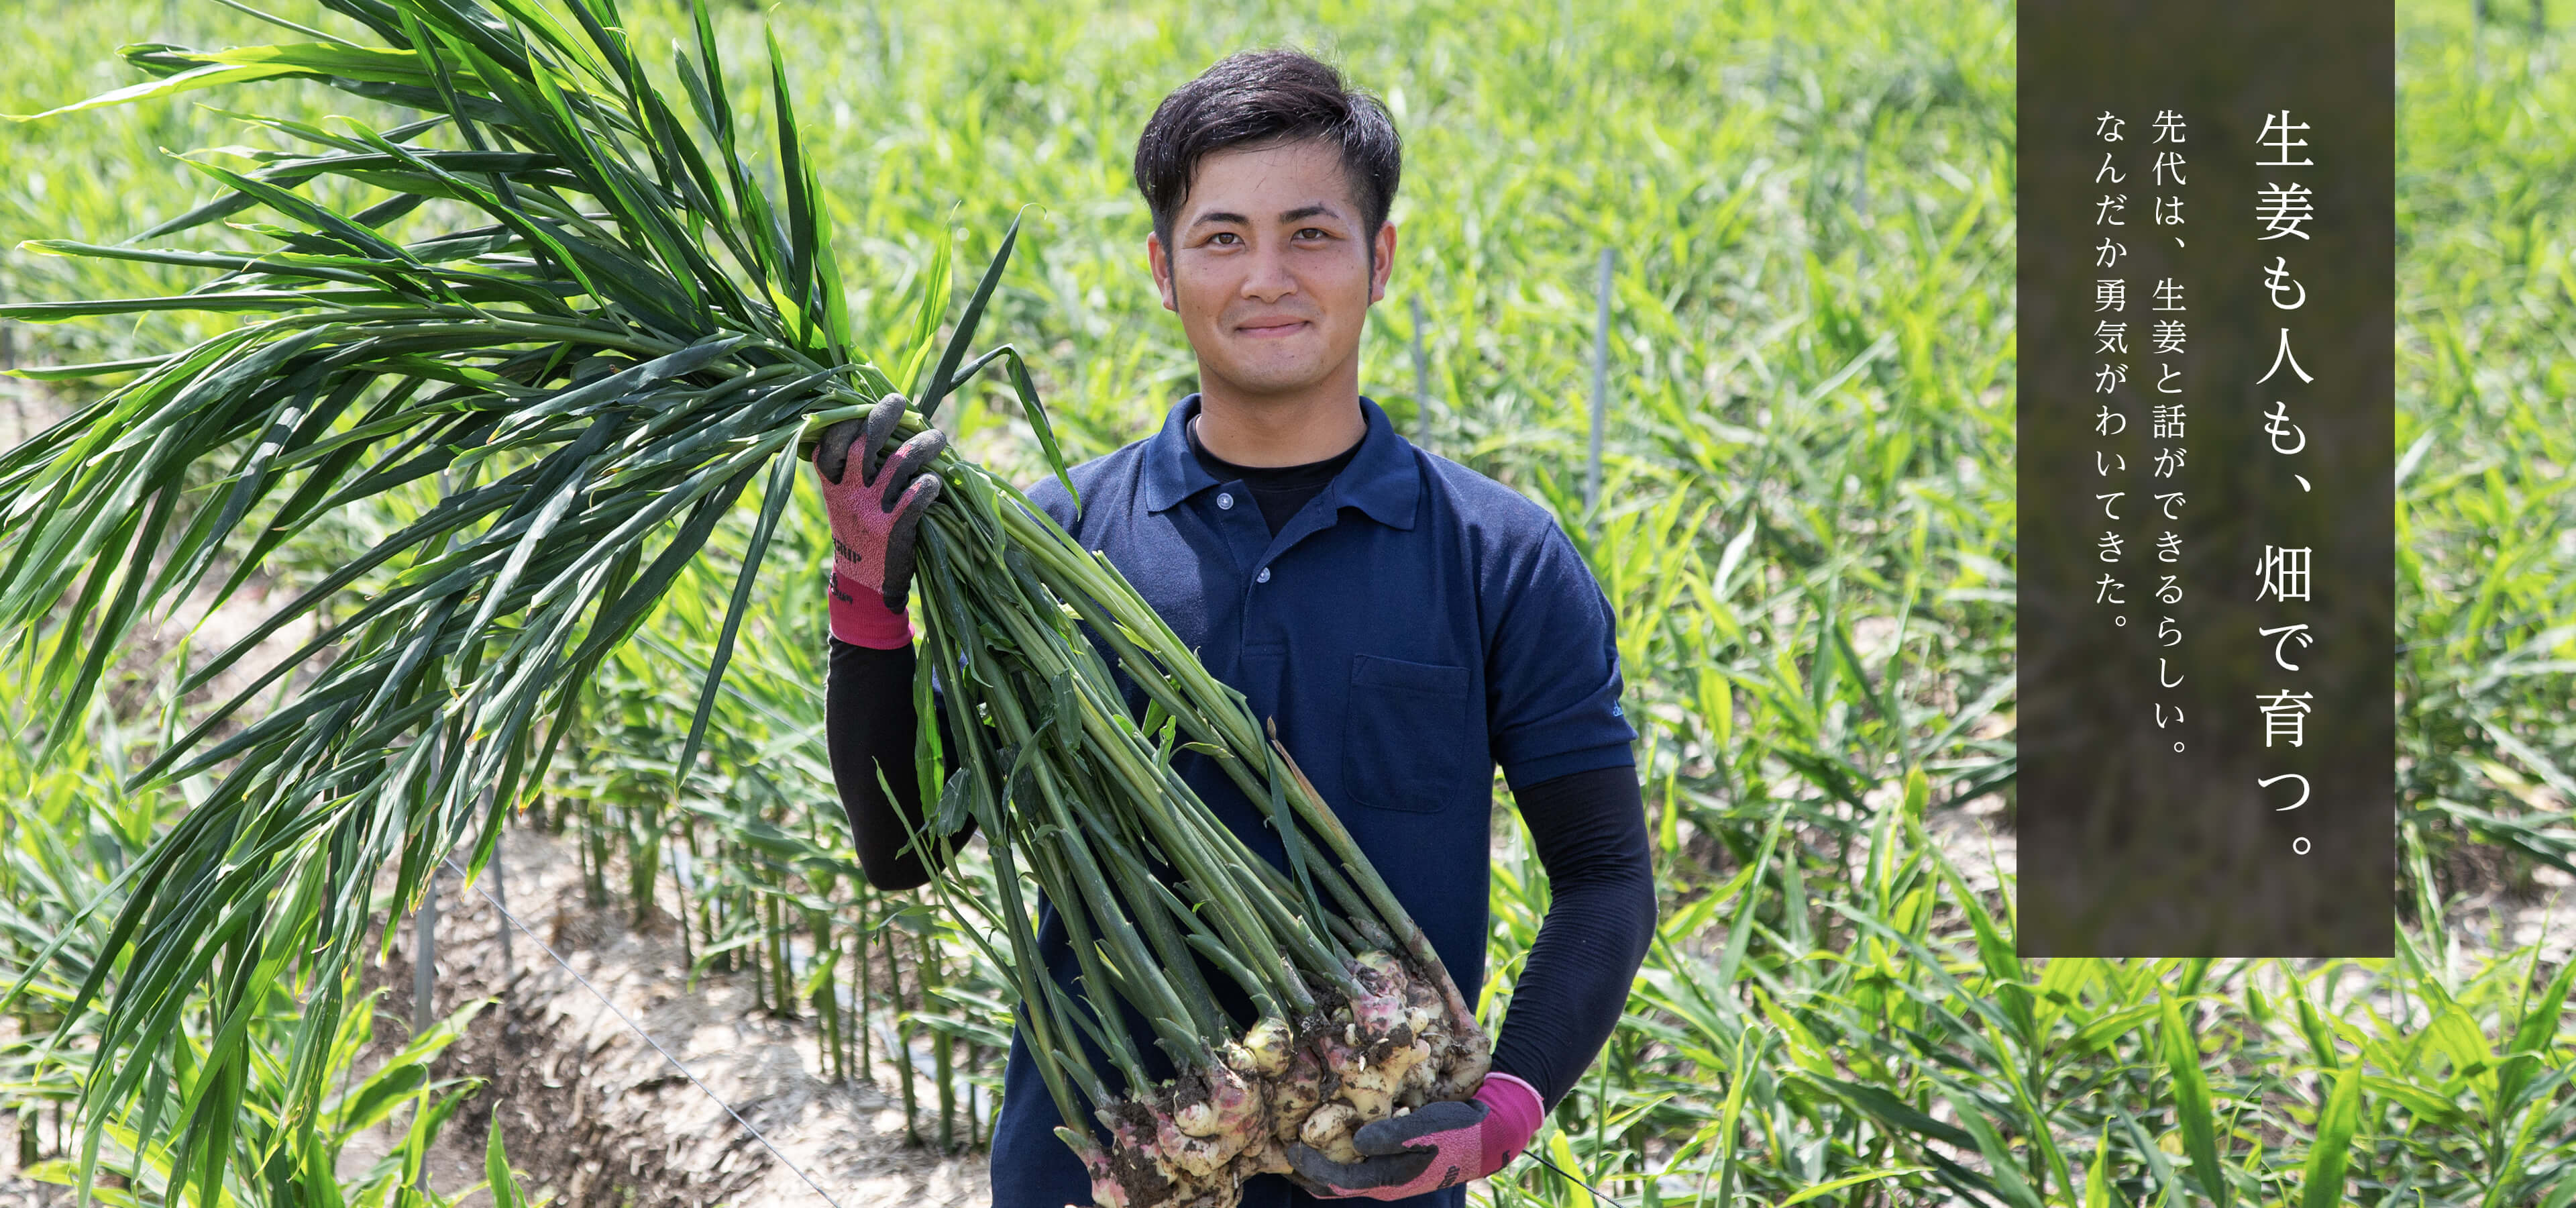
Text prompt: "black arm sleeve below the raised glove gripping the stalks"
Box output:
[[824, 639, 974, 889]]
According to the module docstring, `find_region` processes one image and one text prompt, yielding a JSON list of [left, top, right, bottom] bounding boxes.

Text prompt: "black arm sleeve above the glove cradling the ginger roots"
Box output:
[[1494, 765, 1654, 1107]]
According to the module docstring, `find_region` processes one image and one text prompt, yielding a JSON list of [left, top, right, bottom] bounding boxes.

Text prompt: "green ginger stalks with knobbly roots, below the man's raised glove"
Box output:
[[899, 427, 1491, 1208]]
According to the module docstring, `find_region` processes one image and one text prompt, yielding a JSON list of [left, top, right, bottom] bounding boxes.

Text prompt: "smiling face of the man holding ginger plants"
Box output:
[[1146, 139, 1396, 399]]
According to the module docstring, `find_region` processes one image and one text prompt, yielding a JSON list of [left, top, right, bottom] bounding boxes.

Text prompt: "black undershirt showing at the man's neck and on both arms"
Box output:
[[824, 427, 1654, 1107]]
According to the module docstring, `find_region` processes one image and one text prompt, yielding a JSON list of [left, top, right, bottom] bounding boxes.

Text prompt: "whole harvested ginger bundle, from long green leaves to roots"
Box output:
[[0, 0, 1487, 1208]]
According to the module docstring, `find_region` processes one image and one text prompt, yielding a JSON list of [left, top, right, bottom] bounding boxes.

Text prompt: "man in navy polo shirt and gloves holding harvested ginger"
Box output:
[[816, 52, 1654, 1208]]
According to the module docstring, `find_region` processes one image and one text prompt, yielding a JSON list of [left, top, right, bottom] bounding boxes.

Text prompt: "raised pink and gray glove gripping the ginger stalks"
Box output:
[[814, 394, 948, 649]]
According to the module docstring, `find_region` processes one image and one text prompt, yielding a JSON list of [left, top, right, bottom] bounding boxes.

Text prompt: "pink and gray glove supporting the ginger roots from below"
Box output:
[[1288, 1074, 1546, 1200]]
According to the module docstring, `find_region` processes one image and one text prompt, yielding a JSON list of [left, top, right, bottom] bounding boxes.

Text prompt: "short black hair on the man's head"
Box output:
[[1136, 49, 1404, 268]]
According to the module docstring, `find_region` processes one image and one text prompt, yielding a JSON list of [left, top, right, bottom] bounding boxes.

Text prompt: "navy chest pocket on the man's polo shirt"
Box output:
[[1342, 654, 1487, 814]]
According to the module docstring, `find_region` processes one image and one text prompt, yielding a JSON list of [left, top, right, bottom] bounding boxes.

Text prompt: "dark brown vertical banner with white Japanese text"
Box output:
[[2015, 0, 2396, 956]]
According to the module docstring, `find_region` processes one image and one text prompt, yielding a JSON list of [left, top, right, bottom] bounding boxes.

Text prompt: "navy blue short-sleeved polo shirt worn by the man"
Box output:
[[991, 394, 1635, 1208]]
